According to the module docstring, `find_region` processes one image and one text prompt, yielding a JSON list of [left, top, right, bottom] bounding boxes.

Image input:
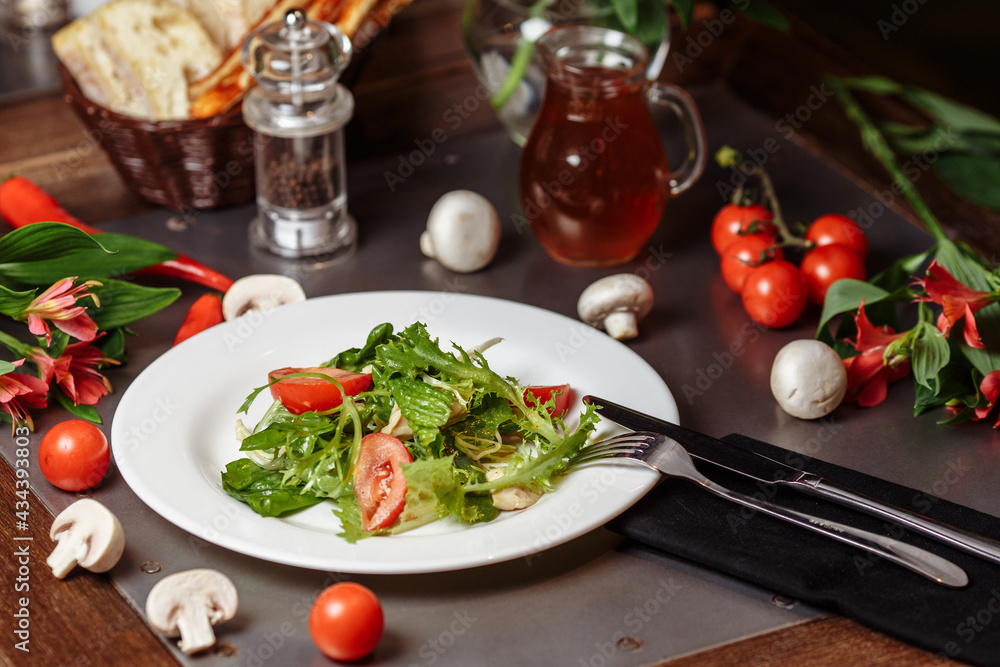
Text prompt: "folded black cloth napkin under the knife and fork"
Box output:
[[608, 435, 1000, 666]]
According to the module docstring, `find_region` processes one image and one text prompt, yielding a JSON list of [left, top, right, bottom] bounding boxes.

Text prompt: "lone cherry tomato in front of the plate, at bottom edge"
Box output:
[[309, 581, 385, 661]]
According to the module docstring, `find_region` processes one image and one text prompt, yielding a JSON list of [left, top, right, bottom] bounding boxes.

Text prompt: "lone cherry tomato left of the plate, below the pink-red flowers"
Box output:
[[38, 419, 111, 491]]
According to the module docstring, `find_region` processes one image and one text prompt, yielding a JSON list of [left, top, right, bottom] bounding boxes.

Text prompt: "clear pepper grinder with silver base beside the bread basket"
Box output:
[[242, 9, 357, 262]]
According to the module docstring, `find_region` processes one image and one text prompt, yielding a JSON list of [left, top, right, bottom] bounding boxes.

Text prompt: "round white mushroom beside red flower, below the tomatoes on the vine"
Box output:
[[771, 338, 847, 419]]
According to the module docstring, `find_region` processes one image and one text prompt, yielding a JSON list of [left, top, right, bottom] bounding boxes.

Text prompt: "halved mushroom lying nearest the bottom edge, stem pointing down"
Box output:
[[146, 568, 238, 653]]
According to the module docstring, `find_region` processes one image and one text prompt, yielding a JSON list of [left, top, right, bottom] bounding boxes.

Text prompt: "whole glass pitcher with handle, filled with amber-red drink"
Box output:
[[520, 26, 706, 267]]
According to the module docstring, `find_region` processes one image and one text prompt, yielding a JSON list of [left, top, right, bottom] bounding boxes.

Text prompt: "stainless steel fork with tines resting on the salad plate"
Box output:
[[572, 431, 969, 588]]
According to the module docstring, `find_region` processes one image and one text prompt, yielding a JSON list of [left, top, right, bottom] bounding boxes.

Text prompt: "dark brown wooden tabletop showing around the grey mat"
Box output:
[[0, 0, 1000, 666]]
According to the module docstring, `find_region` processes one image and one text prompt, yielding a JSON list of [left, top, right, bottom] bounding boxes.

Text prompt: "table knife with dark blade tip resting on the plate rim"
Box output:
[[583, 396, 1000, 564]]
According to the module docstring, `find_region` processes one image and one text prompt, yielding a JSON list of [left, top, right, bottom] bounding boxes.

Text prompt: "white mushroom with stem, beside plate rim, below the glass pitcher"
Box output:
[[576, 273, 653, 340]]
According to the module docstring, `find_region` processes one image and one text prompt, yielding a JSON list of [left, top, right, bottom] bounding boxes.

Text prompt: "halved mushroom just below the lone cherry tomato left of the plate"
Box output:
[[45, 498, 125, 579]]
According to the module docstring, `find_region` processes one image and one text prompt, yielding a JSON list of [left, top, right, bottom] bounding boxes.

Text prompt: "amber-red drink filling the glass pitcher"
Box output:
[[520, 67, 669, 266]]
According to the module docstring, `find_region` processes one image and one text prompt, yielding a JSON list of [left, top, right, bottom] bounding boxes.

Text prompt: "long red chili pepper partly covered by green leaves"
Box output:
[[0, 176, 233, 292]]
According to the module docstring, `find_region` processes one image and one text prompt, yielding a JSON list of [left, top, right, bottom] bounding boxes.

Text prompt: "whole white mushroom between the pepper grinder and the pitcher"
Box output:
[[420, 190, 500, 273]]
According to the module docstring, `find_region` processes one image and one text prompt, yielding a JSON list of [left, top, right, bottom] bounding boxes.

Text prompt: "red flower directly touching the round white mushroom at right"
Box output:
[[844, 302, 910, 408]]
